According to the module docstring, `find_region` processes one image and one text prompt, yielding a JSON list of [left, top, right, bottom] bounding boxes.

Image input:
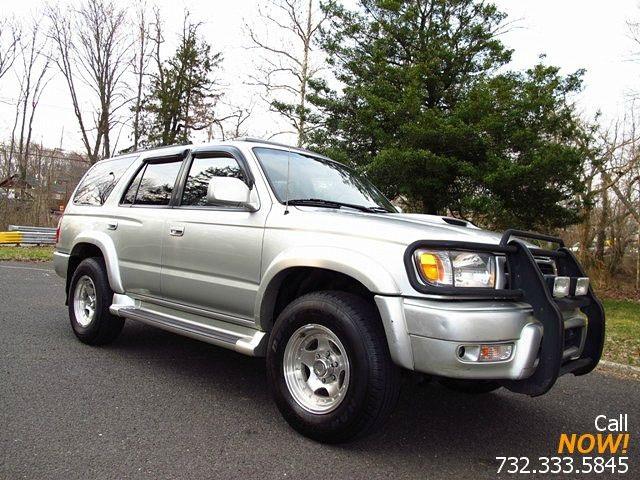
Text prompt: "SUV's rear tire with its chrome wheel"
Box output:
[[68, 257, 124, 345]]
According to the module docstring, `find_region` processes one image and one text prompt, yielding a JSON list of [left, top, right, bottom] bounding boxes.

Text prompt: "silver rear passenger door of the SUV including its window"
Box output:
[[111, 155, 184, 297]]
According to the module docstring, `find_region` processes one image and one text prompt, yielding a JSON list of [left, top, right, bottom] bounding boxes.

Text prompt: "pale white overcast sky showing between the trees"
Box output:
[[0, 0, 640, 154]]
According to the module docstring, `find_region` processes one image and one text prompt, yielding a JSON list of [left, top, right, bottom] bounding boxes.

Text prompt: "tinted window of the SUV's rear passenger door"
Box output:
[[122, 160, 182, 206]]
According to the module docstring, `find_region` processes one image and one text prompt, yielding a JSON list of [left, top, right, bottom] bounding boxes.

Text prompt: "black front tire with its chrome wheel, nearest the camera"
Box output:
[[267, 291, 400, 443]]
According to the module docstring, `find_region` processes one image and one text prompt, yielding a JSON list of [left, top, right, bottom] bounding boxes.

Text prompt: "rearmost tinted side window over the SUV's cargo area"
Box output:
[[73, 157, 135, 205]]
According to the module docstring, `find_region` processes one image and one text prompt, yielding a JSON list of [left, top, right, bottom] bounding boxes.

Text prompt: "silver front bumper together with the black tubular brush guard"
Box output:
[[376, 230, 605, 396]]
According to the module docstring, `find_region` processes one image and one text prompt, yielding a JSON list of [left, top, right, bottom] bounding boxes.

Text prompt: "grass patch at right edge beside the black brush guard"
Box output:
[[603, 299, 640, 367]]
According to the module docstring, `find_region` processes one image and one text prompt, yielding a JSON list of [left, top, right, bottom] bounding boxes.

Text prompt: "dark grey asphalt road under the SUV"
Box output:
[[0, 263, 640, 480]]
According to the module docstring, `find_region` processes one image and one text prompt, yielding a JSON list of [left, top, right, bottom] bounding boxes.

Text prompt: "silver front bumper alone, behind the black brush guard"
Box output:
[[376, 296, 588, 380]]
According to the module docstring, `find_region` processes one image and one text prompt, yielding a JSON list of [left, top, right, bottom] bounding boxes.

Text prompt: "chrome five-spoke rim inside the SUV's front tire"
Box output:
[[283, 324, 350, 413]]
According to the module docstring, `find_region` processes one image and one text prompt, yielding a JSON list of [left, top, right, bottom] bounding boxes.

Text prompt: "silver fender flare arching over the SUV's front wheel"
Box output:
[[254, 246, 400, 330]]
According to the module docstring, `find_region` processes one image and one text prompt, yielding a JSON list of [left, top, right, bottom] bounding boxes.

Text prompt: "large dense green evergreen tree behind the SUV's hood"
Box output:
[[310, 0, 587, 229]]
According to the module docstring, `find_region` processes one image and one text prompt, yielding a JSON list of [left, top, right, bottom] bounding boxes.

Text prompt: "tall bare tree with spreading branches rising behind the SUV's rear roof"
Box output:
[[47, 0, 131, 163]]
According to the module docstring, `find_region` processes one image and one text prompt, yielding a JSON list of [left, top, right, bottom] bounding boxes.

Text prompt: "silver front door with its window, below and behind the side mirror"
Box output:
[[161, 148, 268, 322]]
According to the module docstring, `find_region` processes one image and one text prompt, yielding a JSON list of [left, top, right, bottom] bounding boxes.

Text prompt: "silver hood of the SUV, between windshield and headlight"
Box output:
[[296, 206, 501, 245]]
